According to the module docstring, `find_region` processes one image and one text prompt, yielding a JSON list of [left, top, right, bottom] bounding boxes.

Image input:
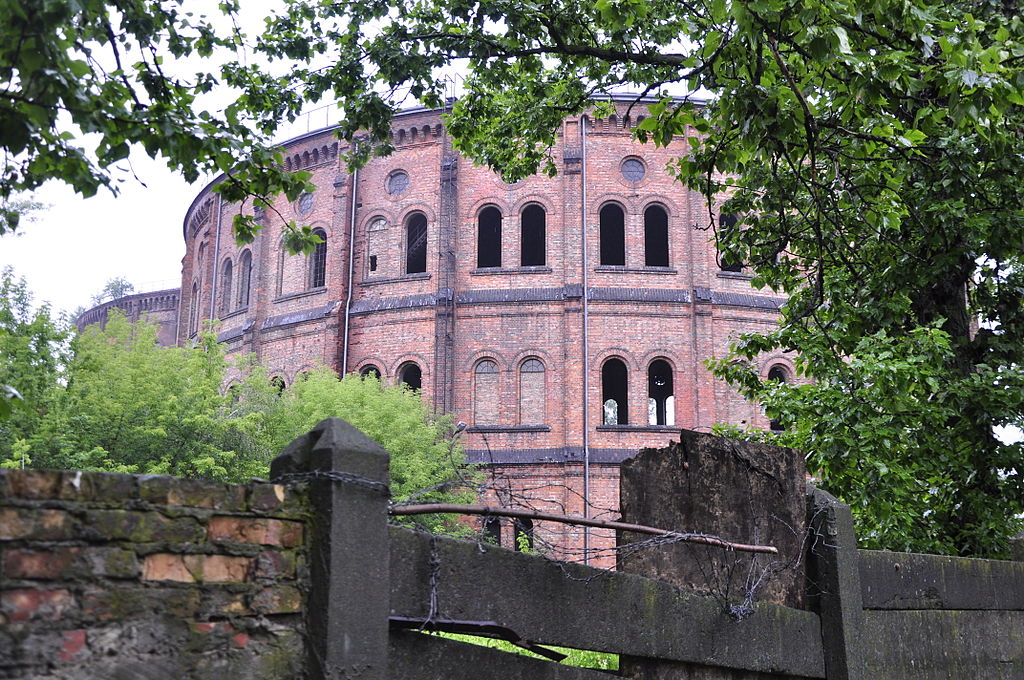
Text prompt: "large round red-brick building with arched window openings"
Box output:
[[86, 97, 793, 555]]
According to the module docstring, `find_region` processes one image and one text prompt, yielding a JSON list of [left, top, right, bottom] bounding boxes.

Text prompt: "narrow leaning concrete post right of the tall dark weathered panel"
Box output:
[[807, 486, 867, 680]]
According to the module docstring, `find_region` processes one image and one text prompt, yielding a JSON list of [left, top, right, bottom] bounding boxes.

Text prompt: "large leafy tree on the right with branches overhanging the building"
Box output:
[[237, 0, 1024, 555]]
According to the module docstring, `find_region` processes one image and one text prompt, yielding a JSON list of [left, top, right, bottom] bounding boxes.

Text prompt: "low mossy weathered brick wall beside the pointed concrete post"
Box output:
[[0, 470, 308, 680]]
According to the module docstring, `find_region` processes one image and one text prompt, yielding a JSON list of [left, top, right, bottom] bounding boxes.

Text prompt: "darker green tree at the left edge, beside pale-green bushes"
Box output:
[[0, 267, 70, 456]]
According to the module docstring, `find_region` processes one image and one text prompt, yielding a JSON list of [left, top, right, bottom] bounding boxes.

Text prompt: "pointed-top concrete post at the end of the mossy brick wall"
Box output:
[[270, 418, 390, 680]]
